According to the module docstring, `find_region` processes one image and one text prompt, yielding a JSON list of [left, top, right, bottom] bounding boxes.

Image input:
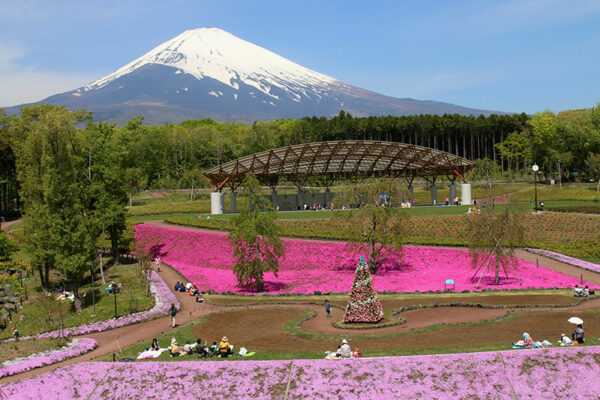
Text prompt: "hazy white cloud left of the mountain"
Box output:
[[0, 43, 98, 107]]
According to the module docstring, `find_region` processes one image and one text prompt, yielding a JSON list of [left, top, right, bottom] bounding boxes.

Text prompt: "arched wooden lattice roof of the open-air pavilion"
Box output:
[[204, 140, 475, 190]]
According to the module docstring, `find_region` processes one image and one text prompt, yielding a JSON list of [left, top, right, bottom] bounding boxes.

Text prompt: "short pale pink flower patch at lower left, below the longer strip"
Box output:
[[0, 338, 98, 378]]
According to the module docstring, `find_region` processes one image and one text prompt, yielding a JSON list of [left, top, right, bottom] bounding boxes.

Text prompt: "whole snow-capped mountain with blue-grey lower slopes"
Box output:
[[8, 28, 500, 124]]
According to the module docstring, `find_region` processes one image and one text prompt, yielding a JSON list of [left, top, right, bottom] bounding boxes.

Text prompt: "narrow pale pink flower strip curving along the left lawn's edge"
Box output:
[[0, 271, 181, 343]]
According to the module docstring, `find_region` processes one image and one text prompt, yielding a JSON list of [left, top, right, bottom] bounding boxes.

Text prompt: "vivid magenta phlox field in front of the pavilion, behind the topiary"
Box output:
[[135, 224, 594, 294]]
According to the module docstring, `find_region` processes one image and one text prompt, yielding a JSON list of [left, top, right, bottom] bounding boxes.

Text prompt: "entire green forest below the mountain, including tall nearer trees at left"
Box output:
[[0, 105, 600, 291]]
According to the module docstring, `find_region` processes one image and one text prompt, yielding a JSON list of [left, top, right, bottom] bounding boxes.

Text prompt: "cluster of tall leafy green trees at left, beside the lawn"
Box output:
[[3, 105, 127, 305]]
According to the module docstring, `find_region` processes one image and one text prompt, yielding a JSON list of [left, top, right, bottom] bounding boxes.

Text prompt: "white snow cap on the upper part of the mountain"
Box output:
[[85, 28, 337, 98]]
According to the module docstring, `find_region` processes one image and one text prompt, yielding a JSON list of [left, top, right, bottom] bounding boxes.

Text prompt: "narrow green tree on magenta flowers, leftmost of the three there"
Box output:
[[229, 175, 284, 291]]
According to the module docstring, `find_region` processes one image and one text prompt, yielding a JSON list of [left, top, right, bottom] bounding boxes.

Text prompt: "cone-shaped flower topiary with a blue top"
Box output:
[[344, 256, 383, 323]]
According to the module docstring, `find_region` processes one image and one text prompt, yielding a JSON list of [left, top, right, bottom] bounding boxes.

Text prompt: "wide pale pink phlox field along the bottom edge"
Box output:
[[0, 346, 600, 400]]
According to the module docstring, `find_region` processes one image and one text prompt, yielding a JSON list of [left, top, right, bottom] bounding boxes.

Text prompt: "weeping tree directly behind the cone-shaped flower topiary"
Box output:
[[333, 178, 410, 274]]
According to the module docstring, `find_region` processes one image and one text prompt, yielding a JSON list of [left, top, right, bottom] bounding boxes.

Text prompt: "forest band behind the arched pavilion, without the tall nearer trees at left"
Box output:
[[0, 105, 600, 213]]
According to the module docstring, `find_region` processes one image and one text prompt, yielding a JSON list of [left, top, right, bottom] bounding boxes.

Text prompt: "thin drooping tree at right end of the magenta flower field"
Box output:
[[466, 203, 523, 287]]
